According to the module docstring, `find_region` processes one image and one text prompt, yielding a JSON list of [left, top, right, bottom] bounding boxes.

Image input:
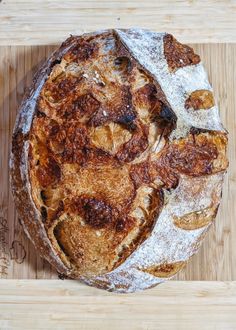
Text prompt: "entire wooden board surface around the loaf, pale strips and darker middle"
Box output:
[[0, 0, 236, 330]]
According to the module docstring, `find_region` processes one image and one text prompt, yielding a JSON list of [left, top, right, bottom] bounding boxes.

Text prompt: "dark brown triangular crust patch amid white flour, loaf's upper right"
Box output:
[[164, 34, 200, 71]]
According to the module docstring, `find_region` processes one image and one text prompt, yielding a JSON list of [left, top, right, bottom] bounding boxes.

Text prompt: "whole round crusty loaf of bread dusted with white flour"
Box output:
[[10, 29, 228, 292]]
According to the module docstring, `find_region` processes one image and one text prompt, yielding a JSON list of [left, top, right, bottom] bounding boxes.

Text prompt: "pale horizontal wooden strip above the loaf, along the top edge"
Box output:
[[0, 0, 236, 45]]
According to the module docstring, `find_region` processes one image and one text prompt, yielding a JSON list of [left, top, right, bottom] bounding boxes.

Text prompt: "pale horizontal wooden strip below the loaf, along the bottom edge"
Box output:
[[0, 280, 236, 330]]
